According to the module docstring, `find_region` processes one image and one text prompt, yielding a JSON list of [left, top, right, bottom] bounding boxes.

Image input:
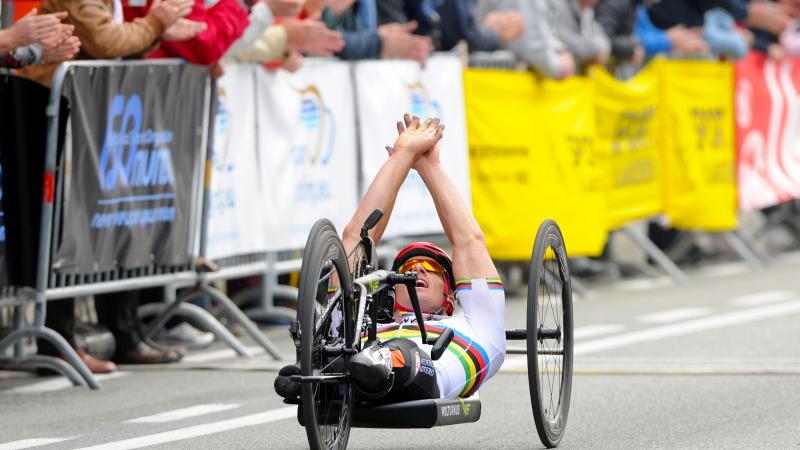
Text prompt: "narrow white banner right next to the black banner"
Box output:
[[206, 64, 267, 259]]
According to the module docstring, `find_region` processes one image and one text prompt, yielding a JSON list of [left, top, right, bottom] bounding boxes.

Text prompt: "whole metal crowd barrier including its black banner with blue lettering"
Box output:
[[0, 60, 280, 388]]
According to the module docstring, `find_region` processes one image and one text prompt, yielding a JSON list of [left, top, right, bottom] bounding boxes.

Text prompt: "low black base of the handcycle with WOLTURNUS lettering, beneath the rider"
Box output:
[[353, 394, 481, 428]]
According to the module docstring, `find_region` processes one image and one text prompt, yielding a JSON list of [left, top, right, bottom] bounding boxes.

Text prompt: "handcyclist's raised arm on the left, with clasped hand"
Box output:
[[342, 115, 443, 252]]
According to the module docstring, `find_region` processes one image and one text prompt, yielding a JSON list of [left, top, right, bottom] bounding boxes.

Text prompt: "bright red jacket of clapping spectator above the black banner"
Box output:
[[123, 0, 250, 66]]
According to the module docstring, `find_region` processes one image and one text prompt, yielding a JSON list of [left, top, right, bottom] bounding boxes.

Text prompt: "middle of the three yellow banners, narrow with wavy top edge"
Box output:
[[593, 61, 663, 230]]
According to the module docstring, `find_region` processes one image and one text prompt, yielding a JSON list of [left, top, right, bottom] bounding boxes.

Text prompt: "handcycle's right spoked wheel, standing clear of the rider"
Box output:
[[527, 220, 573, 448]]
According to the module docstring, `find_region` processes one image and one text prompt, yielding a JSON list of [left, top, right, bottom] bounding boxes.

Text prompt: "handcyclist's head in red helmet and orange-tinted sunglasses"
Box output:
[[392, 242, 456, 315]]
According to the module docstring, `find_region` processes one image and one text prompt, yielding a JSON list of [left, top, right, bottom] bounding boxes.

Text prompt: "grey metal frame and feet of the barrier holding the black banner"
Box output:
[[0, 60, 281, 389]]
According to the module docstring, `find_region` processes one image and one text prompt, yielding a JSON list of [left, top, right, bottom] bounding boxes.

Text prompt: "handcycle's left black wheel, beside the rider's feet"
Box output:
[[297, 219, 355, 450]]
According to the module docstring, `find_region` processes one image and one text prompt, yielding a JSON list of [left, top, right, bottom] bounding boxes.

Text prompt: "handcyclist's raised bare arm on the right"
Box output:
[[404, 115, 498, 279]]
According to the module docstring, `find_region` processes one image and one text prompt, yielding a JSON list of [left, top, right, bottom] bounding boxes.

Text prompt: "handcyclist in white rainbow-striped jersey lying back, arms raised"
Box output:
[[275, 114, 505, 401]]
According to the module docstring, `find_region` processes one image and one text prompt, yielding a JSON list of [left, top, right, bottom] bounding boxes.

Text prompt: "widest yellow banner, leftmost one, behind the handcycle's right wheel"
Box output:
[[464, 70, 606, 260]]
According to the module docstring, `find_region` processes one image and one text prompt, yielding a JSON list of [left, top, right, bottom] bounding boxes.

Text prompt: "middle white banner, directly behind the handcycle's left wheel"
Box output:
[[255, 60, 358, 250]]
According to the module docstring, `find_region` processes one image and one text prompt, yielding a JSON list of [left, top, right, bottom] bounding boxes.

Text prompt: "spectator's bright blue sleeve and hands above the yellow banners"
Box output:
[[634, 5, 708, 58]]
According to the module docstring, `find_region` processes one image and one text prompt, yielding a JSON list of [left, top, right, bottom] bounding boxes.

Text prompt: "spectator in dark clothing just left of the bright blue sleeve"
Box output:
[[595, 0, 646, 66]]
